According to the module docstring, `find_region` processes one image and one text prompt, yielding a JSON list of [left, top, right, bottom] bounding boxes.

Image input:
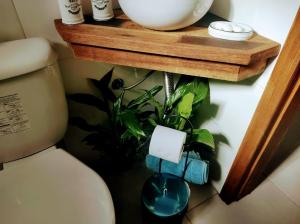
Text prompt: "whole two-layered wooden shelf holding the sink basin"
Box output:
[[55, 11, 280, 81]]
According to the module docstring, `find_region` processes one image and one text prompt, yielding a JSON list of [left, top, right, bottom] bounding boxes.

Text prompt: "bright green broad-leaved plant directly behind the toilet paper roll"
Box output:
[[147, 76, 215, 153]]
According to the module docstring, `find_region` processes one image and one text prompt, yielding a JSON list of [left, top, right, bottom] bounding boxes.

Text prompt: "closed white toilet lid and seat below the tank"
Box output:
[[0, 147, 115, 224]]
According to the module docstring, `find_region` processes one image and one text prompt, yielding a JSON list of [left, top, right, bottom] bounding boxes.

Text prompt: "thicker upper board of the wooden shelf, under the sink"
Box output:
[[55, 12, 280, 65]]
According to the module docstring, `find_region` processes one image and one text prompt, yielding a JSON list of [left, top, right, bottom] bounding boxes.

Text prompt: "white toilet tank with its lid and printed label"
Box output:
[[0, 38, 68, 163]]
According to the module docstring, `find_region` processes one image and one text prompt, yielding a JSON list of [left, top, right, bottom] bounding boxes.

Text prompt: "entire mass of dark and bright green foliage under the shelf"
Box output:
[[68, 69, 214, 170]]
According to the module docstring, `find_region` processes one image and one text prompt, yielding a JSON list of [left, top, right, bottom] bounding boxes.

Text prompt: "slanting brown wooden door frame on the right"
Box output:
[[220, 10, 300, 203]]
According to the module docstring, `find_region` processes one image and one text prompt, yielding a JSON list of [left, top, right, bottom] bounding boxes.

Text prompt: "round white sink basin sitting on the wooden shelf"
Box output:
[[119, 0, 213, 30]]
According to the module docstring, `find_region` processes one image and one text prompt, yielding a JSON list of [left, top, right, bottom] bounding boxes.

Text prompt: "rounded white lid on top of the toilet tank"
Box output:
[[0, 37, 57, 80]]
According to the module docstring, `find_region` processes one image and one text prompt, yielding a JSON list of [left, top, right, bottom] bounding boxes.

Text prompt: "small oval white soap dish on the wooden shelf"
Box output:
[[208, 21, 253, 41]]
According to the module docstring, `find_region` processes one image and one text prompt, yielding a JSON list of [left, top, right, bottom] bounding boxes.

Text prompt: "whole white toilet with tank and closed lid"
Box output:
[[0, 38, 115, 224]]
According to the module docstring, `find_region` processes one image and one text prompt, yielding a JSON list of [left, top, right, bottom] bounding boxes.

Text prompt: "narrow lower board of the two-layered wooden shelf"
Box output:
[[71, 44, 266, 81]]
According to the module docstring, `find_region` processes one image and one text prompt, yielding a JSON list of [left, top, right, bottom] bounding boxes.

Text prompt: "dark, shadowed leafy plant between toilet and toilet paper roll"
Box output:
[[68, 69, 163, 170]]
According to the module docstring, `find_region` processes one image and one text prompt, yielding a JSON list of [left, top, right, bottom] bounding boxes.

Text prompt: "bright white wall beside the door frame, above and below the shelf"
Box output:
[[204, 0, 300, 191]]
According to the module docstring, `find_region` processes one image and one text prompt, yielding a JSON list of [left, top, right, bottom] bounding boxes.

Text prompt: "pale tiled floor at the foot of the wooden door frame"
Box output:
[[187, 146, 300, 224]]
